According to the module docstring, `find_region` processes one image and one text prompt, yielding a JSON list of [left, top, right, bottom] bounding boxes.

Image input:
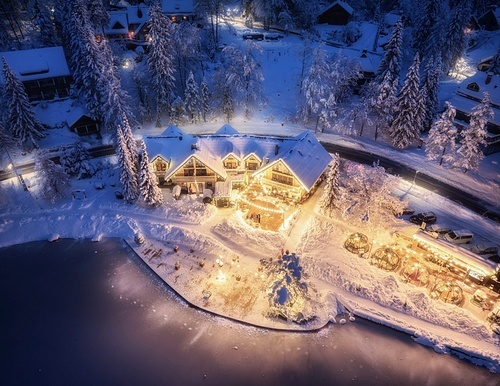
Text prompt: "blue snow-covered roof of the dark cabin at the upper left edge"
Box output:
[[0, 47, 70, 82]]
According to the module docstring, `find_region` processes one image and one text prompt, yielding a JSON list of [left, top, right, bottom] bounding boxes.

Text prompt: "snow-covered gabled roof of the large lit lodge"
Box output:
[[144, 126, 331, 190]]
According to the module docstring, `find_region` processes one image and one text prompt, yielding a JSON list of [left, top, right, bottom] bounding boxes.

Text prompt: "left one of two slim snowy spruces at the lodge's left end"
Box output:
[[116, 125, 139, 203]]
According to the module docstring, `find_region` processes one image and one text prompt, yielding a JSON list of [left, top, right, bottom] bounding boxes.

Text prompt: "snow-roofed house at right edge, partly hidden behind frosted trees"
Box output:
[[449, 71, 500, 155]]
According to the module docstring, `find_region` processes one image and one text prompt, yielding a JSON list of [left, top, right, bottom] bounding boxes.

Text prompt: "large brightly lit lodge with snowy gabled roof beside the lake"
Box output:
[[144, 125, 331, 201]]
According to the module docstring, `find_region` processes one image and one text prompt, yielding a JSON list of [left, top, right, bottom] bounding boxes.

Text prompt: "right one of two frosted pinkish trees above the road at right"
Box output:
[[455, 92, 494, 173]]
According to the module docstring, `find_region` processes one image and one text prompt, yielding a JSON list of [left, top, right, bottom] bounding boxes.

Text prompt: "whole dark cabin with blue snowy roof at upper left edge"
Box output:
[[0, 47, 72, 102]]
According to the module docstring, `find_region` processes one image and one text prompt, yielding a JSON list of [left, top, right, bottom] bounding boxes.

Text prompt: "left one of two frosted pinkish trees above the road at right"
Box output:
[[425, 102, 457, 165]]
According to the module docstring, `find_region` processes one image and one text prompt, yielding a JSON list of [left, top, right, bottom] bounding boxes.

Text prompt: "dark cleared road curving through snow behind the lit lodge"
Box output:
[[0, 142, 500, 223]]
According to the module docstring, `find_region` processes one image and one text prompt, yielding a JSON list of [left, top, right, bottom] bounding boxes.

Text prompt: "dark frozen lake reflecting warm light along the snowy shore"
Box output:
[[0, 239, 500, 386]]
